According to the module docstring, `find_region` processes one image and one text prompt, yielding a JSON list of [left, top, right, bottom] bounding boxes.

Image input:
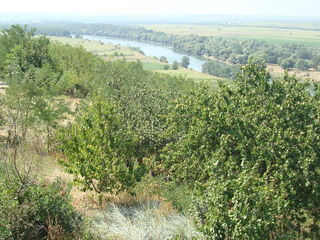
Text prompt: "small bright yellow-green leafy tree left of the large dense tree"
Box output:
[[60, 100, 144, 192]]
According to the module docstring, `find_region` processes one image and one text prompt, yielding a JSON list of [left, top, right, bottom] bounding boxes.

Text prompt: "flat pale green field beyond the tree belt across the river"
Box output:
[[143, 24, 320, 47]]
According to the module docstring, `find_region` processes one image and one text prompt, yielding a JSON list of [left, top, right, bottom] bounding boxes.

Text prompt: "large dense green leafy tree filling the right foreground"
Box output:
[[162, 64, 320, 239]]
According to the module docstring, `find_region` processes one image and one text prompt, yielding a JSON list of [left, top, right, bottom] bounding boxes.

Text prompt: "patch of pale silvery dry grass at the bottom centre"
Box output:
[[94, 202, 203, 240]]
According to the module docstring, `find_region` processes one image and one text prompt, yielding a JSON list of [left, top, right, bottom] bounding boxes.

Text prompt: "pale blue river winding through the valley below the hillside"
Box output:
[[83, 35, 205, 72]]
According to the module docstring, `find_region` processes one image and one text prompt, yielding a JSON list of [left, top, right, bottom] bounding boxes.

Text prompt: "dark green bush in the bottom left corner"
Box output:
[[0, 177, 82, 240]]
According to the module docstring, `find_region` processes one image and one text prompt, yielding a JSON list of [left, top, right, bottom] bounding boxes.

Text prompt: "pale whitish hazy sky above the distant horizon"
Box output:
[[0, 0, 320, 16]]
